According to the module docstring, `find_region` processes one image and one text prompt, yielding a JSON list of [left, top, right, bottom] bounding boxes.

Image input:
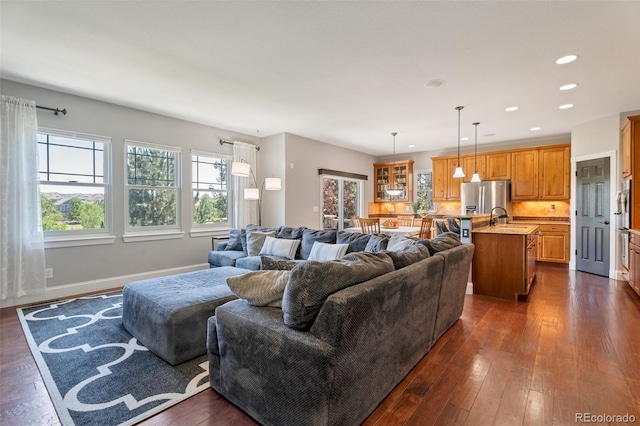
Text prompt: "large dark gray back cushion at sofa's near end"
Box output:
[[282, 252, 394, 330]]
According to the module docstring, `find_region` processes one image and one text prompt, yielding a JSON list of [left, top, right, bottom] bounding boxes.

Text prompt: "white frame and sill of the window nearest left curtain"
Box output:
[[37, 126, 115, 248]]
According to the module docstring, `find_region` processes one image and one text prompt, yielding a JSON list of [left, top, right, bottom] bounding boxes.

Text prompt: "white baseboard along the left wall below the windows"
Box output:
[[2, 263, 209, 308]]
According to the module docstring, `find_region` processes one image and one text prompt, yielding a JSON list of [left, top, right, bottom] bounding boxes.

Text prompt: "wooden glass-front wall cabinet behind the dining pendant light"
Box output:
[[373, 161, 413, 203]]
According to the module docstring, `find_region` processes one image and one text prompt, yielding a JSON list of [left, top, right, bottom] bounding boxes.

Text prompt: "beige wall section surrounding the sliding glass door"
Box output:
[[284, 133, 375, 228]]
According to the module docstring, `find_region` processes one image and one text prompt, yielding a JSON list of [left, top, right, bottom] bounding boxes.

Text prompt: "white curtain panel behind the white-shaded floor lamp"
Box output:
[[233, 142, 259, 228]]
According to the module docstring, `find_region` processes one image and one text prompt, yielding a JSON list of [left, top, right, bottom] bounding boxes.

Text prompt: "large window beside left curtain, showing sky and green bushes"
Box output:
[[38, 128, 111, 240]]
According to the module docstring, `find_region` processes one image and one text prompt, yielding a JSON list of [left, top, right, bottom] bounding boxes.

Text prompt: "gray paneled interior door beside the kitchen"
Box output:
[[576, 157, 611, 277]]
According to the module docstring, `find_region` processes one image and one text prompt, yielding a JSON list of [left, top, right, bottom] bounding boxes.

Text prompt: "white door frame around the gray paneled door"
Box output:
[[569, 151, 622, 279]]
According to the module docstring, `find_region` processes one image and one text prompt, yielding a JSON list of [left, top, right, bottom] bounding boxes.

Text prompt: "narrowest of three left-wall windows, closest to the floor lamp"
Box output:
[[191, 152, 231, 227]]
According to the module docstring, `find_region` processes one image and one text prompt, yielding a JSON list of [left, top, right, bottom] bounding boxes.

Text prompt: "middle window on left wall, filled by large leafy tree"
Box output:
[[125, 140, 180, 232]]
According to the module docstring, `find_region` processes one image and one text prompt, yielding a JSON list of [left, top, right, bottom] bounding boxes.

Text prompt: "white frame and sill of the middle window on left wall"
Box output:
[[123, 139, 184, 242]]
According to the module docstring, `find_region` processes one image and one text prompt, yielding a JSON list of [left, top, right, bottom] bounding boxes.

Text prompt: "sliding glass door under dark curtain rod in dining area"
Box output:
[[322, 175, 363, 230]]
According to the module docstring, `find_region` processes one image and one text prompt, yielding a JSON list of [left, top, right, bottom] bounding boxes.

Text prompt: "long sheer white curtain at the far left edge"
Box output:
[[0, 95, 46, 300]]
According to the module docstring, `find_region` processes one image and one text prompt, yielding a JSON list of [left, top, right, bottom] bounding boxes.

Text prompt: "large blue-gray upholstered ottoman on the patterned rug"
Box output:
[[122, 266, 249, 365]]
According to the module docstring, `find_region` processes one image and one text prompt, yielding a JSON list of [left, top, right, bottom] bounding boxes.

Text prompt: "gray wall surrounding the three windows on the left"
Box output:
[[0, 80, 258, 303]]
